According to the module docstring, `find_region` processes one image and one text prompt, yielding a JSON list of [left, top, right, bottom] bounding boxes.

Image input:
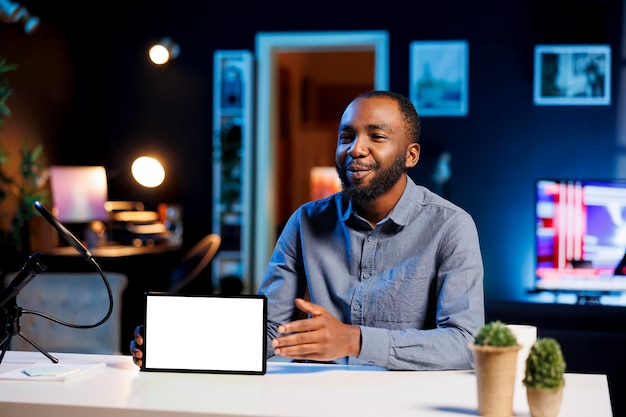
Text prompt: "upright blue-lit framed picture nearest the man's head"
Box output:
[[409, 41, 469, 116]]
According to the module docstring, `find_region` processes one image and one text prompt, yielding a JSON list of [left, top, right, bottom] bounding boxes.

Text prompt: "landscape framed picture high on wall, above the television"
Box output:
[[533, 45, 611, 106]]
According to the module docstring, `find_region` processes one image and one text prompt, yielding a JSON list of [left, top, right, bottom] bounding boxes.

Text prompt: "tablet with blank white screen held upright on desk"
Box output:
[[142, 292, 267, 375]]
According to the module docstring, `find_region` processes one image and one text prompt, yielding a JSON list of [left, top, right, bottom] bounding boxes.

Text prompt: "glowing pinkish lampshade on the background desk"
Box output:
[[50, 165, 109, 224]]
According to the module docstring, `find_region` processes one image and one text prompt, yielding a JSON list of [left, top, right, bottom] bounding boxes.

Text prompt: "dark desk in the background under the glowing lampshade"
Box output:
[[42, 243, 182, 352]]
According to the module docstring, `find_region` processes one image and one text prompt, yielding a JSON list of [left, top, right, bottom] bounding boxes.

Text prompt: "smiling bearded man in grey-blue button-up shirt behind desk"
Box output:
[[131, 91, 484, 370]]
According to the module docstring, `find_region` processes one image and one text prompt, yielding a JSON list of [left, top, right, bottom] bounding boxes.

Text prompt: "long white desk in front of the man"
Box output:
[[0, 351, 613, 417]]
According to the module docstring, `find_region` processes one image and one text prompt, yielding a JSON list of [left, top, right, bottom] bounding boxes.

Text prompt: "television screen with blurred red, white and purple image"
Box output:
[[535, 179, 626, 293]]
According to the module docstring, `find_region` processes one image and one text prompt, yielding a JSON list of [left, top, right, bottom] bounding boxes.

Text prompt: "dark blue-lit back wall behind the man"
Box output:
[[0, 0, 625, 300]]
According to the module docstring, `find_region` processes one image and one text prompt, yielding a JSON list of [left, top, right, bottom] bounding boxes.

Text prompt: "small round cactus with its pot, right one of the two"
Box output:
[[522, 337, 567, 417]]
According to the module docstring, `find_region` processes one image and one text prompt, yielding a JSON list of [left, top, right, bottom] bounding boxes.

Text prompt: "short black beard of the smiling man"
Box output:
[[335, 154, 406, 207]]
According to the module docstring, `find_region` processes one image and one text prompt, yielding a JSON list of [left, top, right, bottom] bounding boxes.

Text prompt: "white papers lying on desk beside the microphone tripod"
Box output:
[[0, 362, 106, 382]]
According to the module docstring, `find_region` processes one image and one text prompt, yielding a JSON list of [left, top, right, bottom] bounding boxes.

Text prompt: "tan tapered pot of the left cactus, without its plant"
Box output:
[[470, 344, 522, 417]]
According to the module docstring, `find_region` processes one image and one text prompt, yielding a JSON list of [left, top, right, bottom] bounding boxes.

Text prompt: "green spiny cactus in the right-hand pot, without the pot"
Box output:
[[522, 337, 567, 389]]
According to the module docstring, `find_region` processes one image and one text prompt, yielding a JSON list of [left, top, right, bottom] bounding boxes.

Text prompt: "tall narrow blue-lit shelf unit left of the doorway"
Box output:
[[211, 50, 253, 292]]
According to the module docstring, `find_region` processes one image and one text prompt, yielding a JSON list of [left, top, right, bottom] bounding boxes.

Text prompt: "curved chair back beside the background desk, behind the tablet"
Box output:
[[168, 233, 222, 292]]
